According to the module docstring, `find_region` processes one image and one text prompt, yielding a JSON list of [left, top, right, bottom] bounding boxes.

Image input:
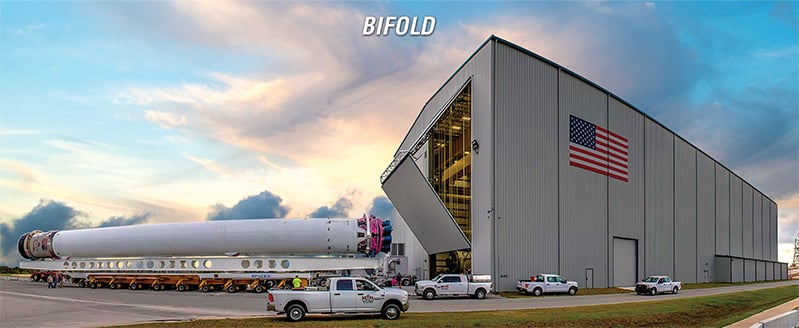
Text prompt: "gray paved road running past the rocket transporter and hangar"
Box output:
[[0, 280, 799, 328]]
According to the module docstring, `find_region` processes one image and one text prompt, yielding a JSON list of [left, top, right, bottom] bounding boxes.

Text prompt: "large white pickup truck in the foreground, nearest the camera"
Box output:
[[266, 277, 409, 321]]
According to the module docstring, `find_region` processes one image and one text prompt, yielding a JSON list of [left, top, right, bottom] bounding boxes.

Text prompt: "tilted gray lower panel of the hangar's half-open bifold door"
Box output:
[[383, 156, 471, 254]]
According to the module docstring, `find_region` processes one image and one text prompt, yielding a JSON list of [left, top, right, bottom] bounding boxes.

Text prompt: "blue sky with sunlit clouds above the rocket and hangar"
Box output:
[[0, 1, 799, 265]]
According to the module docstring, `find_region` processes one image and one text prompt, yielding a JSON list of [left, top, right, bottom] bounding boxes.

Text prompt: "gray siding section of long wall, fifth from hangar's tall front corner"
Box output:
[[674, 138, 697, 283]]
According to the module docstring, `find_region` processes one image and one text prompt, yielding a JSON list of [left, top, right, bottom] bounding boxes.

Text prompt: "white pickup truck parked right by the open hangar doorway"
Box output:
[[414, 274, 494, 300]]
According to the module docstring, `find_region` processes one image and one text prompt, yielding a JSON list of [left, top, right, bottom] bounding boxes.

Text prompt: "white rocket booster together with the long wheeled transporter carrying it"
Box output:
[[17, 215, 392, 292]]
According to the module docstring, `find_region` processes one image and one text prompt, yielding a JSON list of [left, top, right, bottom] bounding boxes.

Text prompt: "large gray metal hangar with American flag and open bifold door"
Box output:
[[381, 36, 787, 290]]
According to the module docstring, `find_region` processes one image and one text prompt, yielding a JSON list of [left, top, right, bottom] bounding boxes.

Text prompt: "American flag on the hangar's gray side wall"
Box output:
[[569, 115, 629, 182]]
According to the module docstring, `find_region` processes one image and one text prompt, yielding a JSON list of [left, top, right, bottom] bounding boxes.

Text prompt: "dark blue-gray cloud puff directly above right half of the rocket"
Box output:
[[208, 190, 290, 220]]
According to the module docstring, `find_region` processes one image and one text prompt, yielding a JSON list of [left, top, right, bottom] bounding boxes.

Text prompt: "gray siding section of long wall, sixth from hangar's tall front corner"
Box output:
[[696, 152, 716, 282]]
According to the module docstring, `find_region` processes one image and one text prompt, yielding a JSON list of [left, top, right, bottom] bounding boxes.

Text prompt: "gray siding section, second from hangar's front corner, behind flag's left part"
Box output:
[[558, 72, 609, 287]]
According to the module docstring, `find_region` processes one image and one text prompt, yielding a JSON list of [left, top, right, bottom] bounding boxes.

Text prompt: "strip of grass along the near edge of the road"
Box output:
[[111, 286, 799, 328]]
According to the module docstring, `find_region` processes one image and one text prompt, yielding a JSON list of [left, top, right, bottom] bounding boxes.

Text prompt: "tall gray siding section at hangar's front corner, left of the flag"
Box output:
[[490, 44, 560, 290]]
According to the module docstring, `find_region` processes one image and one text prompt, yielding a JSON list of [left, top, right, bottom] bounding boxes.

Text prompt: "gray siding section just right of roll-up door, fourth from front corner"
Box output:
[[644, 119, 674, 276]]
